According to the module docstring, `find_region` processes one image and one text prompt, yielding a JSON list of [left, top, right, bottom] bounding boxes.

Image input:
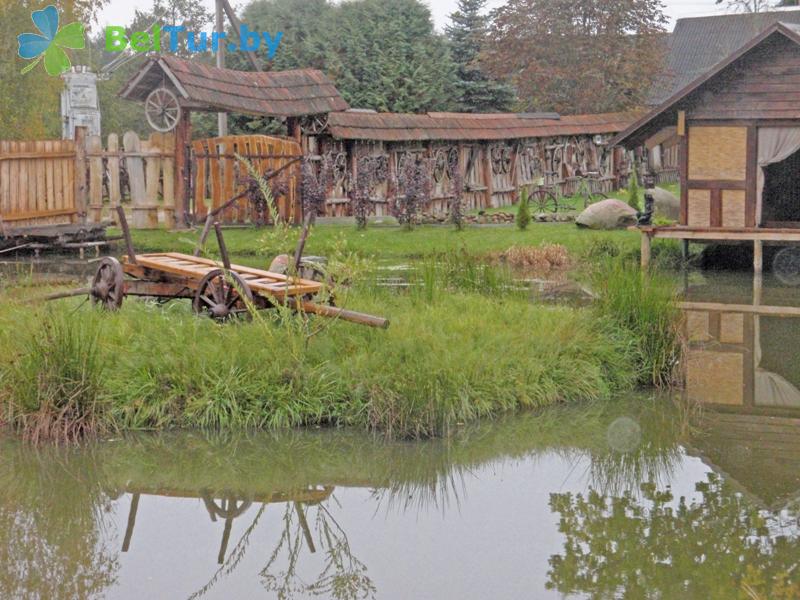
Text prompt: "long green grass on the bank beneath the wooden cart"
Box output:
[[0, 273, 635, 438]]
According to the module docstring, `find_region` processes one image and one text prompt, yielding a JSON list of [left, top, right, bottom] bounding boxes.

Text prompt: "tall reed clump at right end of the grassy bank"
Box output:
[[594, 261, 683, 387]]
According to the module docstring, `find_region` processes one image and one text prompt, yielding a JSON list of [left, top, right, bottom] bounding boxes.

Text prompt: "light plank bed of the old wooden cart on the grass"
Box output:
[[122, 252, 322, 298]]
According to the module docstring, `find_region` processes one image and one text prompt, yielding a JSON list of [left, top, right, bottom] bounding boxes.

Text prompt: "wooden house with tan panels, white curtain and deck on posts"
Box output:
[[612, 22, 800, 271]]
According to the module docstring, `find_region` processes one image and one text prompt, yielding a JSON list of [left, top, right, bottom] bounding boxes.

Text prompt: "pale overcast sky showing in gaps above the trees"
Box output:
[[99, 0, 740, 29]]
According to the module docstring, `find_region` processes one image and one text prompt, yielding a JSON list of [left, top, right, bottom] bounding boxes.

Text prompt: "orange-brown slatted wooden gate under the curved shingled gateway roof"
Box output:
[[191, 135, 303, 223]]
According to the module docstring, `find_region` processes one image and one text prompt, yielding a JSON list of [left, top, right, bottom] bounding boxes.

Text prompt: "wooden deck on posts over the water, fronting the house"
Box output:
[[631, 225, 800, 273]]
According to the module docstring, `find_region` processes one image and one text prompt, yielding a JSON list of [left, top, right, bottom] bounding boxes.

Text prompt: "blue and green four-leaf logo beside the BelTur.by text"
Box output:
[[17, 6, 86, 77]]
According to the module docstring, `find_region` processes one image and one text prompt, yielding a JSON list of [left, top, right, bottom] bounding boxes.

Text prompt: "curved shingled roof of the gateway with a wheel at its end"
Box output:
[[120, 56, 348, 117]]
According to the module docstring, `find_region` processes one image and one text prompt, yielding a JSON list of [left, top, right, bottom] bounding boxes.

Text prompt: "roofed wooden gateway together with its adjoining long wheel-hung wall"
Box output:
[[115, 56, 637, 221]]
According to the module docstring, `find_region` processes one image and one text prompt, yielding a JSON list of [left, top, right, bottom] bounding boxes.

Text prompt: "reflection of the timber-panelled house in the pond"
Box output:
[[684, 281, 800, 511]]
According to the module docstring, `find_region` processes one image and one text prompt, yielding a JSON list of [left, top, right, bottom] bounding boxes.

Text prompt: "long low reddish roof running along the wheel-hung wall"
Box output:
[[328, 111, 638, 142]]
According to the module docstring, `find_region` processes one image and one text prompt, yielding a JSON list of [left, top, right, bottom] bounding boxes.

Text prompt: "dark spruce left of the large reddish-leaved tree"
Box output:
[[445, 0, 514, 112]]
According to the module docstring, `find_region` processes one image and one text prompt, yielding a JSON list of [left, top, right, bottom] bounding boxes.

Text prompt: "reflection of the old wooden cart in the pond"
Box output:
[[114, 485, 335, 564]]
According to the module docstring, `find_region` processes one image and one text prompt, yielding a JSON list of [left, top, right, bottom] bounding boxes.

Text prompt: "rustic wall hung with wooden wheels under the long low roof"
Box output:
[[303, 135, 631, 216]]
